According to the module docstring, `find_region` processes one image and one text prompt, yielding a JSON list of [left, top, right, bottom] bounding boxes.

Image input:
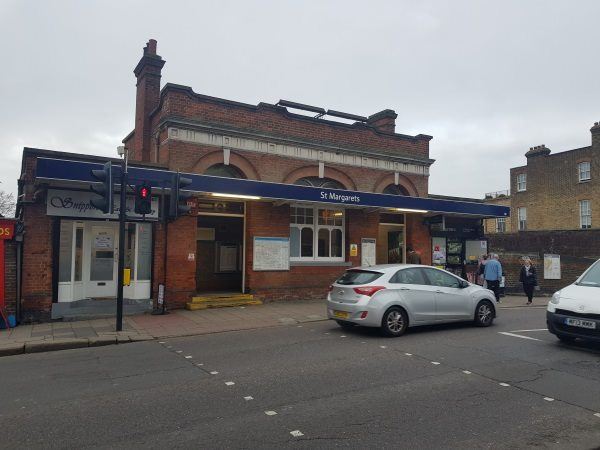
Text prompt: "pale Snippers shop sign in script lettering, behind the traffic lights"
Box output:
[[46, 189, 158, 220]]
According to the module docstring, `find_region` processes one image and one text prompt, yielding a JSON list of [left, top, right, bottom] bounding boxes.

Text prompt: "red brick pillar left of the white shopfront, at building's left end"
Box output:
[[21, 203, 58, 322]]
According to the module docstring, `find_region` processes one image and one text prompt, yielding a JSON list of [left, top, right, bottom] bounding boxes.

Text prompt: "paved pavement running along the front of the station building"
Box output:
[[0, 296, 548, 356]]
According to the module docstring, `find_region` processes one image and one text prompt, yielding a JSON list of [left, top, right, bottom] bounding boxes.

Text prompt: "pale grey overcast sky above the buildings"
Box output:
[[0, 0, 600, 197]]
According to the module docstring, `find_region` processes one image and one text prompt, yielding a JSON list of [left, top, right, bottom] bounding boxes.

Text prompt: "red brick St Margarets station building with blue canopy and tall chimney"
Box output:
[[19, 40, 508, 320]]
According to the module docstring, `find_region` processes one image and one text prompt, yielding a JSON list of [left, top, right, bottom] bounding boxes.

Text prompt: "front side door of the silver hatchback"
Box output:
[[423, 268, 473, 322]]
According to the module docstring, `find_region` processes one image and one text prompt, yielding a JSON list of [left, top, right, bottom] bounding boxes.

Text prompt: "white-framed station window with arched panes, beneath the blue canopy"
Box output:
[[290, 206, 344, 261]]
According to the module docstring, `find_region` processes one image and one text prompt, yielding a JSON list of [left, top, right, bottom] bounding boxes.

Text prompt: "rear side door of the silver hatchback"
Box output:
[[389, 267, 436, 324]]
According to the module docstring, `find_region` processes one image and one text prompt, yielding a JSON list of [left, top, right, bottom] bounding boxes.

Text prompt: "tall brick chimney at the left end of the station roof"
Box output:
[[131, 39, 165, 161]]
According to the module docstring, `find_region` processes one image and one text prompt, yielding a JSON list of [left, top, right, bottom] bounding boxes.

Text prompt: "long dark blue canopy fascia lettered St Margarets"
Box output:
[[36, 157, 510, 217]]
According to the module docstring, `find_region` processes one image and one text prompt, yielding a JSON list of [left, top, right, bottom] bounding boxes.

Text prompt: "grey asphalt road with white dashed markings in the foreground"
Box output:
[[0, 308, 600, 449]]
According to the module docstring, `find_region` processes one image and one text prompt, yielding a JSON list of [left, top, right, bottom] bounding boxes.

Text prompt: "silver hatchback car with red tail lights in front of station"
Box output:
[[327, 264, 497, 336]]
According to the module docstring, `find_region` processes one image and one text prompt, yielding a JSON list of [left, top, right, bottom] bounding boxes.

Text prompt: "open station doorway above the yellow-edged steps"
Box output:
[[196, 215, 244, 293]]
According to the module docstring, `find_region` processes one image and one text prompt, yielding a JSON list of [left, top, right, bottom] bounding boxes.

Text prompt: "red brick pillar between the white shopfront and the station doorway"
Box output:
[[164, 216, 198, 308]]
